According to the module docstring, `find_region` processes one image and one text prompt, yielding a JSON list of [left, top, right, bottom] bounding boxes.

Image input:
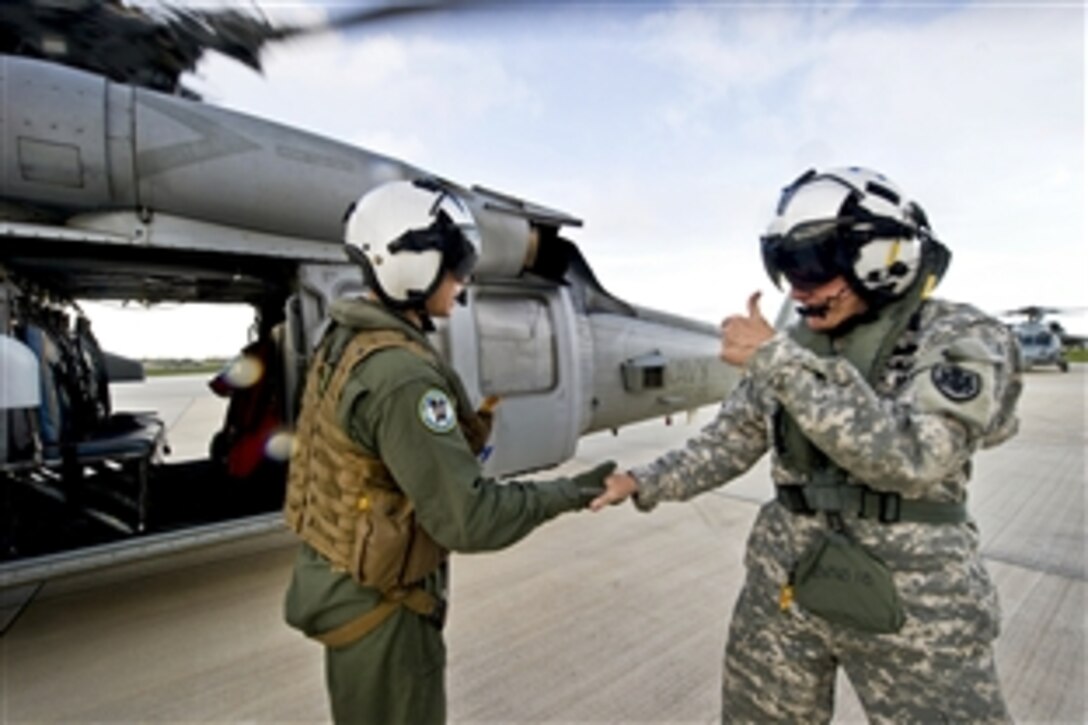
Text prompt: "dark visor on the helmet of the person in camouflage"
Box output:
[[759, 220, 843, 290]]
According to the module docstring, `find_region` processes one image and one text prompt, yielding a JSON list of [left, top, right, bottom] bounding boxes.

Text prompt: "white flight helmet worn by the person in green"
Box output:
[[344, 179, 480, 310]]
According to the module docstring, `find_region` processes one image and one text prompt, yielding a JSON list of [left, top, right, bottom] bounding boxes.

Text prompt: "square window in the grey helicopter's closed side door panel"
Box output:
[[474, 295, 557, 395]]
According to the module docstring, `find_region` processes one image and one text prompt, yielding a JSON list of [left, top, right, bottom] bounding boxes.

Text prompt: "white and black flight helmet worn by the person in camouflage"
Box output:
[[761, 167, 948, 306]]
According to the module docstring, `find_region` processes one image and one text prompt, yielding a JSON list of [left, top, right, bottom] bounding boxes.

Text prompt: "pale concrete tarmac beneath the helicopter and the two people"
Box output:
[[0, 366, 1088, 723]]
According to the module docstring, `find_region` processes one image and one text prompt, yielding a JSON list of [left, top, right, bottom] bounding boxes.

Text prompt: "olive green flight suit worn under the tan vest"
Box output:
[[285, 299, 585, 725]]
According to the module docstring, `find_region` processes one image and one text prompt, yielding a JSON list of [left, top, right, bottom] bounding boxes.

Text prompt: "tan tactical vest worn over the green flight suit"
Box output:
[[284, 330, 490, 592]]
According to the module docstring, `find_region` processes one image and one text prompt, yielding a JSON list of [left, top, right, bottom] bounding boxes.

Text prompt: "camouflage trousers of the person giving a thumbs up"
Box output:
[[721, 504, 1010, 723]]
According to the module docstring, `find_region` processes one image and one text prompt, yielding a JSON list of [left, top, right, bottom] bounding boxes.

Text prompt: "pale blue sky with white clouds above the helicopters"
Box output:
[[82, 1, 1088, 355]]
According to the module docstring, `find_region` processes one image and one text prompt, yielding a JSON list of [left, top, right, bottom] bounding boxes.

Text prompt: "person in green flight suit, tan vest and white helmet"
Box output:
[[284, 180, 614, 724]]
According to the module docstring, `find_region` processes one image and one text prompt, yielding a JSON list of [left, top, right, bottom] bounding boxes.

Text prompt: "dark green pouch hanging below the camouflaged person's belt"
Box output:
[[791, 524, 904, 635]]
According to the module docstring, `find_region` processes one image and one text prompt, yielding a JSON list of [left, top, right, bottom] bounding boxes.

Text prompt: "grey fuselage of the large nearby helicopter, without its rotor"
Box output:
[[0, 56, 737, 587]]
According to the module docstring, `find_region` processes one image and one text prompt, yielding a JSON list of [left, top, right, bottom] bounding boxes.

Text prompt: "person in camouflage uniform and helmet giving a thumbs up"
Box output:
[[593, 168, 1021, 723]]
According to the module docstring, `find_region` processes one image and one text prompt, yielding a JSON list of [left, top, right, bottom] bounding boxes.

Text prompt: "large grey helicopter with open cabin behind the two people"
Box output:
[[0, 0, 737, 589]]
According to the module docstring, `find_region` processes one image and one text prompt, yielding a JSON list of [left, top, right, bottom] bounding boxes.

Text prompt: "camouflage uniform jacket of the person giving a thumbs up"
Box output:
[[631, 299, 1021, 636]]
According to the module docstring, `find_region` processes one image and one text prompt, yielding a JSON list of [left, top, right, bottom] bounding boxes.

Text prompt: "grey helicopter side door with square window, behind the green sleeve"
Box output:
[[448, 282, 582, 476]]
